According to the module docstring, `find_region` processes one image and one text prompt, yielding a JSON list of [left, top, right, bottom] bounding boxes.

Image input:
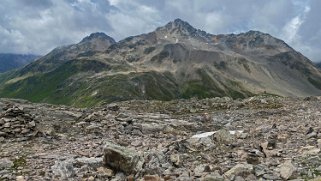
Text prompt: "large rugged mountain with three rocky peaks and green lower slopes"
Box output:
[[0, 19, 321, 106]]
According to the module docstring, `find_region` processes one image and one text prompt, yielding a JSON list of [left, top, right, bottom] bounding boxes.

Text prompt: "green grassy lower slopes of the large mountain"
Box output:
[[0, 60, 250, 107]]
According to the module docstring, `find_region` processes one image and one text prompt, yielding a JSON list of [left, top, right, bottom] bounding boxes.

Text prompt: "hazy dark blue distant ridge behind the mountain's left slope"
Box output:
[[0, 53, 39, 73]]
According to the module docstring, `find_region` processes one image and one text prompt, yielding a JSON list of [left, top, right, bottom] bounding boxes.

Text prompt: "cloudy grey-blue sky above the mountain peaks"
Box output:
[[0, 0, 321, 61]]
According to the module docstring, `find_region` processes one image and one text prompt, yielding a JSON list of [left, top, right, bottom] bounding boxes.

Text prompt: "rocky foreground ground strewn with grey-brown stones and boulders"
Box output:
[[0, 96, 321, 181]]
